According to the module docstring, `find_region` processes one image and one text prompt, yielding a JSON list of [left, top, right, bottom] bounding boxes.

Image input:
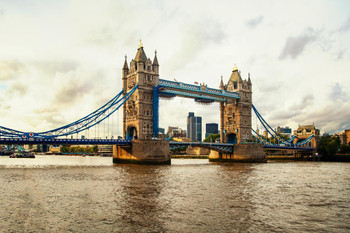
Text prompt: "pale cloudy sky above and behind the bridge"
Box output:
[[0, 0, 350, 135]]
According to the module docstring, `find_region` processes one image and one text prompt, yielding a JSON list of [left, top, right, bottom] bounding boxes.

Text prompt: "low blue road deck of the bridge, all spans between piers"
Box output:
[[0, 138, 314, 153]]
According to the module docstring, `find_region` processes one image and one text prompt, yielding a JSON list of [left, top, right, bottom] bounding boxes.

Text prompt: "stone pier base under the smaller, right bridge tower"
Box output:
[[209, 144, 267, 163]]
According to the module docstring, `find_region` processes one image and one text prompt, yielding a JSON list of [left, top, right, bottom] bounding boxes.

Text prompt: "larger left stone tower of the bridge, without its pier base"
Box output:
[[122, 41, 159, 139]]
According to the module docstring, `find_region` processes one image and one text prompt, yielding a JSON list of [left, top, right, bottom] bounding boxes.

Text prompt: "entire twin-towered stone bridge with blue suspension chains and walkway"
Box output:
[[0, 43, 314, 164]]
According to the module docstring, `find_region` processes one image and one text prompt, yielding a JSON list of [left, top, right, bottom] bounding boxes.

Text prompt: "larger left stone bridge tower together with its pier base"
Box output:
[[113, 41, 171, 164]]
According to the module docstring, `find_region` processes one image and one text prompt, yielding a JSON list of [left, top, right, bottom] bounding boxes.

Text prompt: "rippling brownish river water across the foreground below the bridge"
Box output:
[[0, 156, 350, 232]]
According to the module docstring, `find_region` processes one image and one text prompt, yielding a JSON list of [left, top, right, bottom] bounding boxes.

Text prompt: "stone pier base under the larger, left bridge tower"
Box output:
[[113, 140, 171, 164]]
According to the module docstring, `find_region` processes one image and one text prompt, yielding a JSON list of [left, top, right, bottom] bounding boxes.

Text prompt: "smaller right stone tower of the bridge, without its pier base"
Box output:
[[220, 67, 252, 144]]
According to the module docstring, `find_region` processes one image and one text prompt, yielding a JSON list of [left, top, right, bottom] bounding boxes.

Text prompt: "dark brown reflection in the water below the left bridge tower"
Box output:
[[116, 165, 169, 232]]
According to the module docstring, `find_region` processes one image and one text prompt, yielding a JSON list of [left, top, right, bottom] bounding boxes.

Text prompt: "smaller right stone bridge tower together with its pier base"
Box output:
[[209, 67, 267, 163]]
